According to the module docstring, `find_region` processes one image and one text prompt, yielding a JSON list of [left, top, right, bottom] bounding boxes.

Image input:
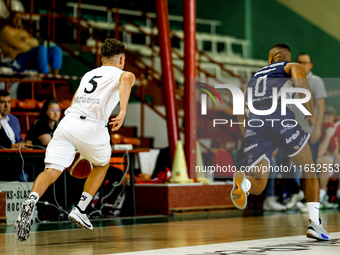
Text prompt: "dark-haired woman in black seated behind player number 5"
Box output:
[[27, 99, 61, 148]]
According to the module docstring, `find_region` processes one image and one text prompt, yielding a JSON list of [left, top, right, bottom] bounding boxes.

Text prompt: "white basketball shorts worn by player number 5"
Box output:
[[45, 115, 111, 171]]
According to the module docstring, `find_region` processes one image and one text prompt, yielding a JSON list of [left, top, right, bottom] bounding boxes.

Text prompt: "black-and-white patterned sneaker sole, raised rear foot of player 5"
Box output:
[[14, 199, 35, 242]]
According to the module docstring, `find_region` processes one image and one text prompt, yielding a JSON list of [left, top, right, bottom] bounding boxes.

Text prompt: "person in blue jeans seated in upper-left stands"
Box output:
[[0, 12, 62, 74]]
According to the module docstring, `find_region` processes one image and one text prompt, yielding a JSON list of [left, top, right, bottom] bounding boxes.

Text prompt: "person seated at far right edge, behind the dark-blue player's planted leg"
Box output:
[[317, 106, 340, 209]]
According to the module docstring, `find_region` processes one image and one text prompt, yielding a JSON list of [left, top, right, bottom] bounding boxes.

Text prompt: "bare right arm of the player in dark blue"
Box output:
[[285, 63, 314, 127]]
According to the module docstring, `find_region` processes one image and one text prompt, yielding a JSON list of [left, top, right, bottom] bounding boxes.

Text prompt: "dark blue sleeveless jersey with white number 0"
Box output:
[[246, 61, 293, 110]]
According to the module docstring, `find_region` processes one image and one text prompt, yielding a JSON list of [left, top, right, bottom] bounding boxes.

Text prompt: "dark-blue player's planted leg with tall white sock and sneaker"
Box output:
[[292, 143, 332, 241]]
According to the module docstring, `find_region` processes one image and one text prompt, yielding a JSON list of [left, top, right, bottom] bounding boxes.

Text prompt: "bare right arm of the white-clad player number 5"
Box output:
[[109, 72, 136, 132]]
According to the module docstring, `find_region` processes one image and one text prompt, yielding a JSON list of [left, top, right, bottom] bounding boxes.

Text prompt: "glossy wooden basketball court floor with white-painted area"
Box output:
[[0, 210, 340, 255]]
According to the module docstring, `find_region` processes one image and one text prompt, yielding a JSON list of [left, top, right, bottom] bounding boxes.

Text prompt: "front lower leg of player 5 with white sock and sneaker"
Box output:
[[68, 162, 110, 230]]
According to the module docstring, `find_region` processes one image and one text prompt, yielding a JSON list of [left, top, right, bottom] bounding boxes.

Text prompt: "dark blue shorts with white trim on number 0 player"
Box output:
[[243, 107, 309, 166]]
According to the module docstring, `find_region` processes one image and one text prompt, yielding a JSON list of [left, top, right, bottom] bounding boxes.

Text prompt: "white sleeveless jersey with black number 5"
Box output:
[[65, 66, 124, 125]]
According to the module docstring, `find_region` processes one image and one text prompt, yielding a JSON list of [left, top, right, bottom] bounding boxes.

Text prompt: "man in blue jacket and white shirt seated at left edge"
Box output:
[[0, 90, 32, 149]]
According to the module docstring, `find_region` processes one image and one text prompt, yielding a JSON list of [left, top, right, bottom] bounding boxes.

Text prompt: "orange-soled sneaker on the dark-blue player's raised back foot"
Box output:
[[230, 172, 249, 209]]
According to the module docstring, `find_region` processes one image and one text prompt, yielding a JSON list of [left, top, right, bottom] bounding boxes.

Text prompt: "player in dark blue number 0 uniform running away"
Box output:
[[231, 44, 331, 240]]
